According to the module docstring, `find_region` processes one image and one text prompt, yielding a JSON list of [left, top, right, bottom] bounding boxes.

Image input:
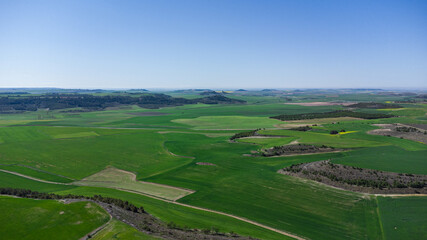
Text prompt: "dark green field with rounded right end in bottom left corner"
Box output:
[[0, 196, 109, 240]]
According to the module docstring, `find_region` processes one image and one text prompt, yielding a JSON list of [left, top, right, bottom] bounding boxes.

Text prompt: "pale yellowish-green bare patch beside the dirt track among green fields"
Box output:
[[74, 167, 193, 201]]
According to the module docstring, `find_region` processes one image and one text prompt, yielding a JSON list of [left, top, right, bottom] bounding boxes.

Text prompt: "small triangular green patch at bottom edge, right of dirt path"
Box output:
[[91, 219, 160, 240]]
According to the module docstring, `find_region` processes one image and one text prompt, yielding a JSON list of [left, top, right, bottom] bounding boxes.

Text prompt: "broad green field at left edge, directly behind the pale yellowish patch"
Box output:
[[0, 127, 191, 179]]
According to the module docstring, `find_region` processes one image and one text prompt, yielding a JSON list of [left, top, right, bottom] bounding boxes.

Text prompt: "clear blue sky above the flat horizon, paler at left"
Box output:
[[0, 0, 427, 88]]
